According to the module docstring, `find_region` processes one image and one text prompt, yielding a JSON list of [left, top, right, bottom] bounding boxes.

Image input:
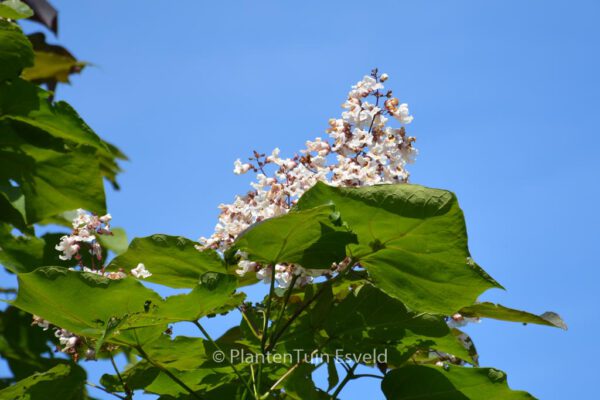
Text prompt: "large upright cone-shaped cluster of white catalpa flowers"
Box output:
[[198, 70, 416, 287]]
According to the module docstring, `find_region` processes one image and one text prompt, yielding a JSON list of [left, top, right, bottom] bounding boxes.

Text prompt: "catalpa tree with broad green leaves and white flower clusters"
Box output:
[[0, 1, 566, 400]]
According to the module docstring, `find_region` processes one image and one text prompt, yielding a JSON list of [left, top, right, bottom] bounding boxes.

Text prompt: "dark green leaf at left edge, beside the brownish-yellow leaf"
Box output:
[[0, 20, 33, 81]]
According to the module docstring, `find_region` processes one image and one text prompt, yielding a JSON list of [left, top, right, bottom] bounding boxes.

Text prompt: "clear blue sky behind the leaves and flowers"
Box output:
[[2, 0, 600, 399]]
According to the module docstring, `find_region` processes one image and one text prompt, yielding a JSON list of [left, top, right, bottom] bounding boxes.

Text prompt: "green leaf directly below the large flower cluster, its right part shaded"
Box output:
[[234, 205, 356, 269]]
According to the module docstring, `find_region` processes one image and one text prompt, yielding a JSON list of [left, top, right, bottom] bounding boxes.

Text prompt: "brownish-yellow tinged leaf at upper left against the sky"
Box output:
[[23, 32, 87, 84]]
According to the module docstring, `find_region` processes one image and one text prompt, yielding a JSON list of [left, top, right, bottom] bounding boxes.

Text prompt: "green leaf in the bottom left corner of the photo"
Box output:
[[0, 364, 86, 400]]
